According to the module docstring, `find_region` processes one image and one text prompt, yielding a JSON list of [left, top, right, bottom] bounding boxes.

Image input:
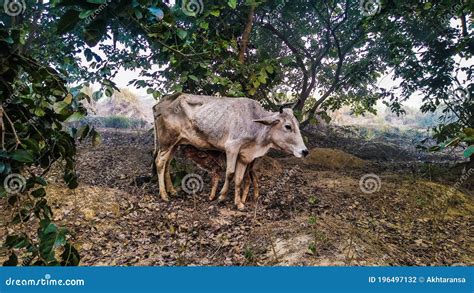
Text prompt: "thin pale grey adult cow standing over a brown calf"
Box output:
[[153, 94, 309, 210]]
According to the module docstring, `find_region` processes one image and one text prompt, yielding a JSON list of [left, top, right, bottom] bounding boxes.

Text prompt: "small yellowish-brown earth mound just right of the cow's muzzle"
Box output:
[[304, 148, 366, 170]]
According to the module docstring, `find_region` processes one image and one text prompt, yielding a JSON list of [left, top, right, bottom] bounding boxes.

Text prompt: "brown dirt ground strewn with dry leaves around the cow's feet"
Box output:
[[1, 130, 474, 266]]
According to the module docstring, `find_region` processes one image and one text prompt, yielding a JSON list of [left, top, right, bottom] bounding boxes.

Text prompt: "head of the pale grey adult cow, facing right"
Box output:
[[254, 108, 308, 158]]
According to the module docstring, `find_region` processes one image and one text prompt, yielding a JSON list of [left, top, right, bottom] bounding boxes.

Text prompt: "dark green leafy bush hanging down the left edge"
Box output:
[[0, 4, 97, 265]]
